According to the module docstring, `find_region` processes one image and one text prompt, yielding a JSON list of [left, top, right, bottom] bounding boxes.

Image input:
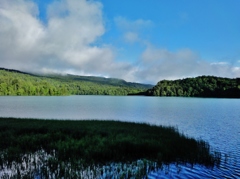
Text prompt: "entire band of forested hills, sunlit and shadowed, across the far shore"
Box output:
[[0, 68, 240, 98]]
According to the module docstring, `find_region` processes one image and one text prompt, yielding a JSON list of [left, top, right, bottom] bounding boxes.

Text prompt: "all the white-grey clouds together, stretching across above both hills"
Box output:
[[0, 0, 240, 84]]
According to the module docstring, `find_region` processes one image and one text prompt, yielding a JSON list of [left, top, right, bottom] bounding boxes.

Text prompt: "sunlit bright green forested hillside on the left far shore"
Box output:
[[0, 68, 153, 96]]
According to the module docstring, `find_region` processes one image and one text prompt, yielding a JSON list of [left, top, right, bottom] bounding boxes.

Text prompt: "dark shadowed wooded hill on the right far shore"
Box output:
[[146, 76, 240, 98]]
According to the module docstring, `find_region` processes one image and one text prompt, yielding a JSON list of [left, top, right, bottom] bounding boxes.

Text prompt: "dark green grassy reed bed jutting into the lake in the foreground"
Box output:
[[0, 118, 219, 178]]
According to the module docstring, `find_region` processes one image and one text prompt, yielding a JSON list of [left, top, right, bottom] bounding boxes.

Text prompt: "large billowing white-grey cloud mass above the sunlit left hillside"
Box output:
[[0, 0, 133, 77]]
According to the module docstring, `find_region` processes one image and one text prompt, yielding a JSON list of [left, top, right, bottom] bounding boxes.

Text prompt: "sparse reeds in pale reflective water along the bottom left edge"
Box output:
[[0, 150, 157, 179]]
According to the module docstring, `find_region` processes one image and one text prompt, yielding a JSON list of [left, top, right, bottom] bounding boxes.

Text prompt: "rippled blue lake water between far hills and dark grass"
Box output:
[[0, 96, 240, 178]]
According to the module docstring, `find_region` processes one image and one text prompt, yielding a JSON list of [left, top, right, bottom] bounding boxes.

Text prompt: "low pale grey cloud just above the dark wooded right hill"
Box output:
[[135, 46, 240, 83]]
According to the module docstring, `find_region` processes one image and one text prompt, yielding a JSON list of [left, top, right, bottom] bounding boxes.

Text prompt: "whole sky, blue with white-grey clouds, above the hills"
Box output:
[[0, 0, 240, 84]]
